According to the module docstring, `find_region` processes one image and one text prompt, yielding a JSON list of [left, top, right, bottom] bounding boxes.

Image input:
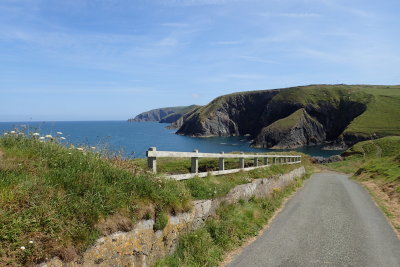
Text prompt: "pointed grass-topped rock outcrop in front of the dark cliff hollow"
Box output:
[[253, 108, 326, 149]]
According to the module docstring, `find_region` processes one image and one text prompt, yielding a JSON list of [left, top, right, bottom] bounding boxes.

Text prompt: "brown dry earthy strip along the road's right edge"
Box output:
[[360, 180, 400, 239]]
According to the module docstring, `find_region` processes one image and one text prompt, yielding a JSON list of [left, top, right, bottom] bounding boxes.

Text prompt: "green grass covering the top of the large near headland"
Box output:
[[188, 85, 400, 136]]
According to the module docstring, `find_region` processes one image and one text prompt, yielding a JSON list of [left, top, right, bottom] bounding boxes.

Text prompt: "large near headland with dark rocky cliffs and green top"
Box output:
[[177, 85, 400, 149]]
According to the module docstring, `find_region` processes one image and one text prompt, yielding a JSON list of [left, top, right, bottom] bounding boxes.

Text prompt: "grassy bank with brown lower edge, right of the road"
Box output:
[[326, 136, 400, 234]]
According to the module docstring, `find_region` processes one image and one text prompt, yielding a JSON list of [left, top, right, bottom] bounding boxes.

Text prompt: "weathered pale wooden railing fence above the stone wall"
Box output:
[[146, 147, 301, 180]]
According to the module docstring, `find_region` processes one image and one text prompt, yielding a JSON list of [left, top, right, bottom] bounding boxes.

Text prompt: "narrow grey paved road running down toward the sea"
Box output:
[[228, 173, 400, 267]]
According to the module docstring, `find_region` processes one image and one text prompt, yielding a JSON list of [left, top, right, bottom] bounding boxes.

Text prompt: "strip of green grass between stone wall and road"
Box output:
[[156, 173, 310, 267]]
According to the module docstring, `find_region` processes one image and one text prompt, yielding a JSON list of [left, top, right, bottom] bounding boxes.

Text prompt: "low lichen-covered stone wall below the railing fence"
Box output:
[[39, 167, 305, 267]]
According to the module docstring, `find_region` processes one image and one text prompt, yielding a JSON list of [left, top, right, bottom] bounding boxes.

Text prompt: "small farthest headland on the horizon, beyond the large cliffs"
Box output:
[[128, 105, 200, 123]]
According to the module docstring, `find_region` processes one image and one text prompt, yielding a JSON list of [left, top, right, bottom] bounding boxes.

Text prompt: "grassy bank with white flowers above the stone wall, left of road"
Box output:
[[0, 134, 306, 266]]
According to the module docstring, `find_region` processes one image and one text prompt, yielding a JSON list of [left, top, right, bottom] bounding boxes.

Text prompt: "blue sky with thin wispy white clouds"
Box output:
[[0, 0, 400, 121]]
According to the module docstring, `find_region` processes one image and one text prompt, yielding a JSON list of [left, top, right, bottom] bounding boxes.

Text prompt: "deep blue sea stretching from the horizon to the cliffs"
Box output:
[[0, 121, 342, 158]]
